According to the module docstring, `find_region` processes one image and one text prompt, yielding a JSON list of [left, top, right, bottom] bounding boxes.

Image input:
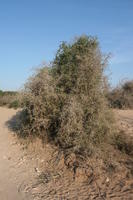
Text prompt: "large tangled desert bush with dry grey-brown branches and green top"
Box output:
[[21, 36, 112, 153]]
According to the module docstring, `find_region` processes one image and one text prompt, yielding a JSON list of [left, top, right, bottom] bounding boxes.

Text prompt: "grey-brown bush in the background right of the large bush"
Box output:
[[108, 80, 133, 109]]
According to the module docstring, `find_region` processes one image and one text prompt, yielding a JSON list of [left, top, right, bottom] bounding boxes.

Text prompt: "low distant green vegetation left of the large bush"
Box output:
[[0, 90, 20, 109]]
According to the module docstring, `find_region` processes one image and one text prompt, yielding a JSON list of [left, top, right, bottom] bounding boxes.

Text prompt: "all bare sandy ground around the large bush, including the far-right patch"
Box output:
[[0, 108, 133, 200]]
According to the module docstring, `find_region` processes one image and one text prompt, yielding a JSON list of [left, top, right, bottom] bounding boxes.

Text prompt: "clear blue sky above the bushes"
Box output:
[[0, 0, 133, 90]]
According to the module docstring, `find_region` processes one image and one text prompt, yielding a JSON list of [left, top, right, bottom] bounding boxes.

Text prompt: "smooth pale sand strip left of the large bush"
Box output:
[[0, 108, 34, 200]]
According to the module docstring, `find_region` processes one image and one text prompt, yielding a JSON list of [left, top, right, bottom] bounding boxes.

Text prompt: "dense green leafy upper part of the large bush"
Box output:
[[52, 36, 98, 93]]
